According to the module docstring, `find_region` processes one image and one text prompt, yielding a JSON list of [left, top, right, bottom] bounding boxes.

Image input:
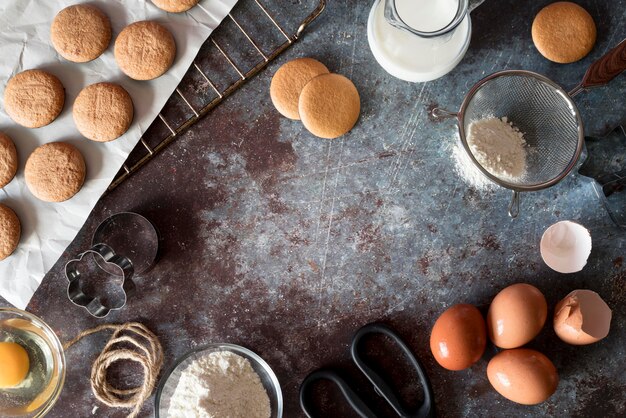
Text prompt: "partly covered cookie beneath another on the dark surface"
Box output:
[[270, 58, 329, 120]]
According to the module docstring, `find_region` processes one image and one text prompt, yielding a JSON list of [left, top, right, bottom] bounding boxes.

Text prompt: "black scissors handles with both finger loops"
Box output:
[[300, 323, 435, 418]]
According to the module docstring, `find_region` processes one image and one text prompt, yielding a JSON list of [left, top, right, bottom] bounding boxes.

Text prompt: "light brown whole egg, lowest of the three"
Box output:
[[487, 348, 559, 405]]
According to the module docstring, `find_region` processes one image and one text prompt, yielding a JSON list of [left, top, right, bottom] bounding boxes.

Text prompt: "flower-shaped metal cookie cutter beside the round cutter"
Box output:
[[65, 243, 135, 318]]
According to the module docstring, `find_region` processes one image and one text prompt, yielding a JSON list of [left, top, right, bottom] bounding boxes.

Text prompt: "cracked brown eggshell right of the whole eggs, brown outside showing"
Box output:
[[554, 289, 612, 345]]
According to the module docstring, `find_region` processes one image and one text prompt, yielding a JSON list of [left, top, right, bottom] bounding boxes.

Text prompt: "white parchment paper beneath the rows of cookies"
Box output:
[[0, 0, 236, 309]]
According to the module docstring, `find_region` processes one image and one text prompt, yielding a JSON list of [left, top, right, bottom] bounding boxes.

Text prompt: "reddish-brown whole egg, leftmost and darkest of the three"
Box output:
[[430, 304, 487, 370]]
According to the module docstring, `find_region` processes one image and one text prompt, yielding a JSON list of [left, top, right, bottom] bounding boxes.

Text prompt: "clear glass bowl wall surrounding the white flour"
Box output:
[[155, 344, 283, 418]]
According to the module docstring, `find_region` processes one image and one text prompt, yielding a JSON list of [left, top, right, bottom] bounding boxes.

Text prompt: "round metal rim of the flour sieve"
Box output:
[[457, 70, 585, 192]]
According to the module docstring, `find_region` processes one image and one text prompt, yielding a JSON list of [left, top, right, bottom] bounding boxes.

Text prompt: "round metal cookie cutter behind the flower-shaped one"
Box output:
[[91, 212, 160, 276]]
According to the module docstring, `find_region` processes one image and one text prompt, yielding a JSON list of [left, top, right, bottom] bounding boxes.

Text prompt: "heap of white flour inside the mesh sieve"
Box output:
[[467, 117, 526, 179]]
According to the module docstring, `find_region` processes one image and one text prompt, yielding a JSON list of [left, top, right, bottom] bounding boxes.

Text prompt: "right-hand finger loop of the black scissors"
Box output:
[[350, 323, 436, 418]]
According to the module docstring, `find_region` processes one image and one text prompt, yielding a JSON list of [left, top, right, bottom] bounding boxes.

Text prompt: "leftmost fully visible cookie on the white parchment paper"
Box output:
[[4, 70, 65, 128]]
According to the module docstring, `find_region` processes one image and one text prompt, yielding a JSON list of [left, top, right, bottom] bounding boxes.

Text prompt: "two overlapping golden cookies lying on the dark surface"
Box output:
[[270, 58, 361, 139]]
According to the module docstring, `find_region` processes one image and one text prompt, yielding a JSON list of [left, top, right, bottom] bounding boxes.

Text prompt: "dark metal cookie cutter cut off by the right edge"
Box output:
[[578, 125, 626, 229]]
